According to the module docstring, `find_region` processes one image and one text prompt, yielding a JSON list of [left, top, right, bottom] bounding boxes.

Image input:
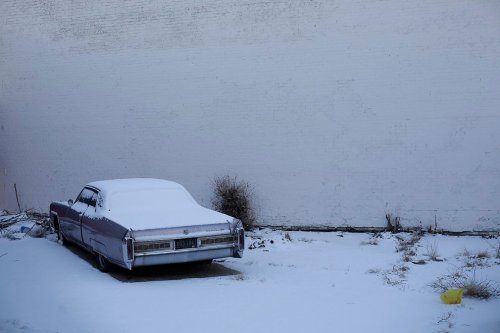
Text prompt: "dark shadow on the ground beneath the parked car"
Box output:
[[66, 244, 241, 282]]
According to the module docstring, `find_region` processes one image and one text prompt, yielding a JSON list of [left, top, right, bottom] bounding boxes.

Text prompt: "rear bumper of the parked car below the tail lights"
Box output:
[[130, 246, 242, 268]]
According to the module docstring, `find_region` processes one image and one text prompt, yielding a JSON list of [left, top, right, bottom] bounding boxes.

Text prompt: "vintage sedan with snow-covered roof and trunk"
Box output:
[[50, 178, 245, 271]]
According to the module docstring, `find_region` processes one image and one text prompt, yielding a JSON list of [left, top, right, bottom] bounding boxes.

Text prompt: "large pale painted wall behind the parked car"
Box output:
[[0, 0, 500, 230]]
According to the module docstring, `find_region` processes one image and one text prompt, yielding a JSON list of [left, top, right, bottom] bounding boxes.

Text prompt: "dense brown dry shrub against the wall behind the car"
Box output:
[[212, 176, 255, 230]]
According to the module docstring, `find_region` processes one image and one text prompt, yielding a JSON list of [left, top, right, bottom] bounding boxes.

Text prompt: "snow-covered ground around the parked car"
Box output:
[[0, 214, 500, 332]]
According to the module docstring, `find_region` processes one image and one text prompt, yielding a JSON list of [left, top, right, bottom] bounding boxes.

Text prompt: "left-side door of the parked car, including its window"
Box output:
[[62, 187, 96, 244]]
